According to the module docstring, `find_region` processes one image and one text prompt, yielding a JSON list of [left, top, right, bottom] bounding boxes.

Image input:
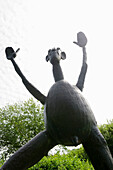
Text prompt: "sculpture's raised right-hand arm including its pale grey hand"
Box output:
[[74, 32, 88, 91]]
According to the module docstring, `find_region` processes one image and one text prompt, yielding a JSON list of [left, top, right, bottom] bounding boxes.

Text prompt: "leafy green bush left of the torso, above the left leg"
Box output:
[[0, 99, 44, 158]]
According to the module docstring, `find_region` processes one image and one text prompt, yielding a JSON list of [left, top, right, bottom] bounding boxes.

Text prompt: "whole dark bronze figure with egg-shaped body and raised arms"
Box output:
[[1, 32, 113, 170]]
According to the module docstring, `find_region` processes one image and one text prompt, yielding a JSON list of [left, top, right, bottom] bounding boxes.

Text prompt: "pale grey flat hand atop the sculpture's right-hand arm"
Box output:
[[73, 32, 87, 48]]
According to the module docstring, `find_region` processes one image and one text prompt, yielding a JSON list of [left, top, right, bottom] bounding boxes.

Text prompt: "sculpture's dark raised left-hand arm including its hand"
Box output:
[[5, 47, 46, 104]]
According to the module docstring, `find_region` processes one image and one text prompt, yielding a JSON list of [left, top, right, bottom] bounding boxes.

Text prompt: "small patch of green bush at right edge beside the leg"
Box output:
[[99, 119, 113, 156]]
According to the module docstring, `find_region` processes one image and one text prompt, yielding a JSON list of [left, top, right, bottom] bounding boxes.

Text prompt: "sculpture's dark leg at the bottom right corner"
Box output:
[[83, 127, 113, 170]]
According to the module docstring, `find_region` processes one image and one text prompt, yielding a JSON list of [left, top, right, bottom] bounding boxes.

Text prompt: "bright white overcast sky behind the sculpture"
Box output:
[[0, 0, 113, 124]]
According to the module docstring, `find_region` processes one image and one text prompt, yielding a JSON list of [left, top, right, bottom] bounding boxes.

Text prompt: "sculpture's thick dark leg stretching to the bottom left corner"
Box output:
[[1, 131, 55, 170]]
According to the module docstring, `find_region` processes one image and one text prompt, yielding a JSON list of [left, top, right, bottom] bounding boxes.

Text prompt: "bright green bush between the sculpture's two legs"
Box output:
[[29, 151, 94, 170]]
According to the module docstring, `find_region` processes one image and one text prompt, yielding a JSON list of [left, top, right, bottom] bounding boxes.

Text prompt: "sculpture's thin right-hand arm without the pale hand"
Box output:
[[76, 47, 88, 91]]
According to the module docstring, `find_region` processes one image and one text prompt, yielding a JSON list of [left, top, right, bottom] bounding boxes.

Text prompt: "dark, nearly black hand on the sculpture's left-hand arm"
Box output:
[[5, 47, 20, 60]]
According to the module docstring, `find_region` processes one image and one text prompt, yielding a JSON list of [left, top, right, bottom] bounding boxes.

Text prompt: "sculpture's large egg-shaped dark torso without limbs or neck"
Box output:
[[46, 80, 96, 145]]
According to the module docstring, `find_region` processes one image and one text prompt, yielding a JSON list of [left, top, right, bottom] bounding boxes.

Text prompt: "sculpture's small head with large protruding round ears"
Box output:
[[46, 48, 66, 65]]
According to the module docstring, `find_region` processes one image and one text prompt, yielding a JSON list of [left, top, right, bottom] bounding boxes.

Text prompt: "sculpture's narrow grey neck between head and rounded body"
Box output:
[[53, 63, 64, 82]]
